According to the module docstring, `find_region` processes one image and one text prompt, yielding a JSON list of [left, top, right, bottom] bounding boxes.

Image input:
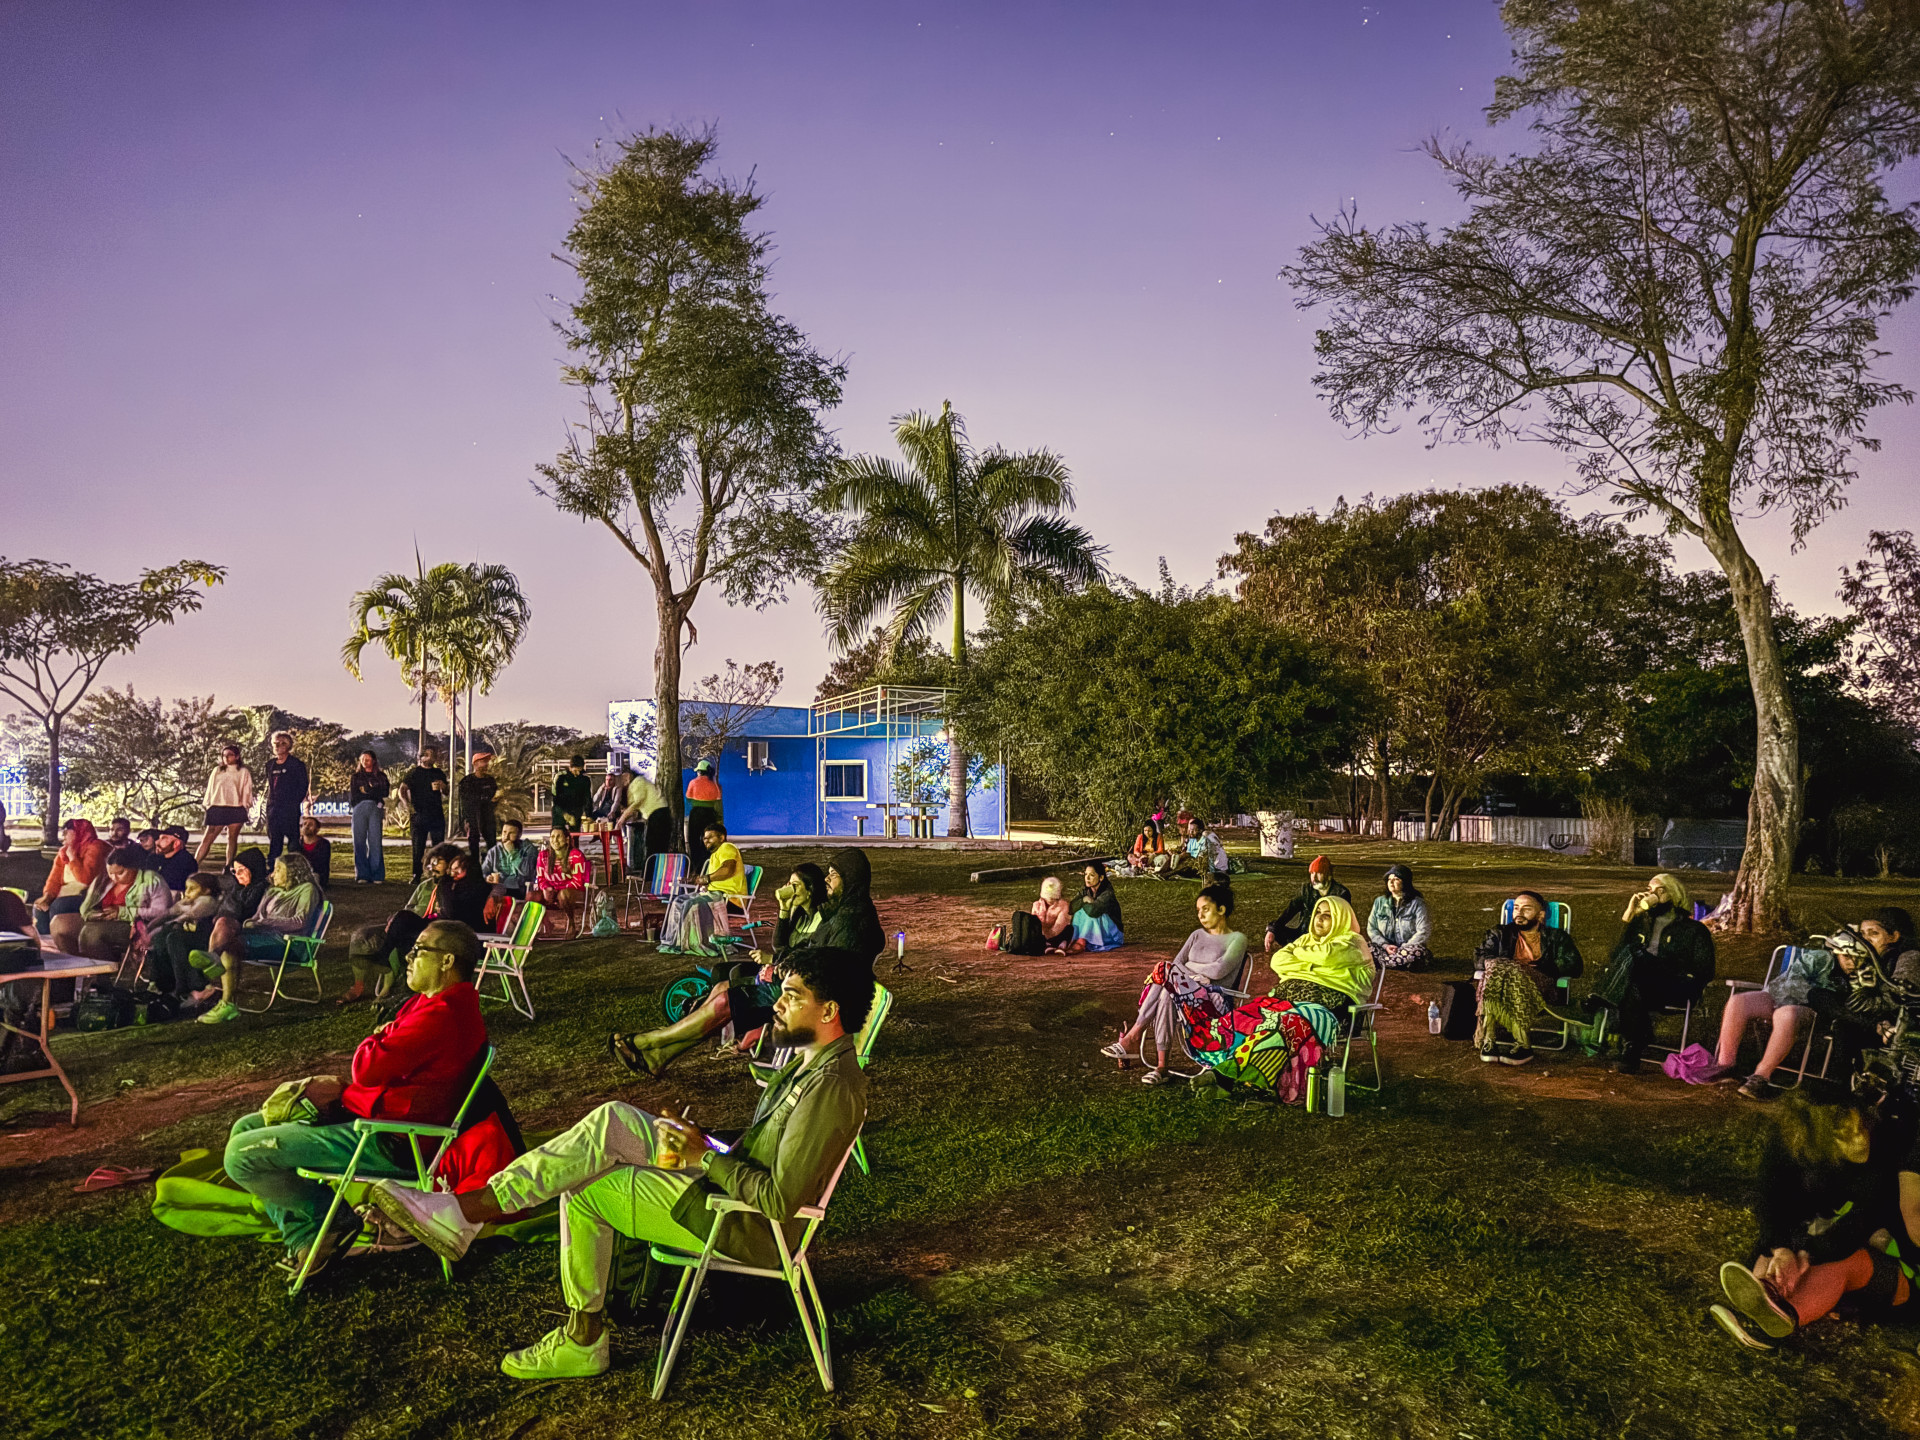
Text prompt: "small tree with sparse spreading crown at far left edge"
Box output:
[[0, 557, 227, 845]]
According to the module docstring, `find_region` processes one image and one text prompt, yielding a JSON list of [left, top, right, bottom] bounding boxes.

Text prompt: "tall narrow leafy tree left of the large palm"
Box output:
[[534, 131, 847, 840]]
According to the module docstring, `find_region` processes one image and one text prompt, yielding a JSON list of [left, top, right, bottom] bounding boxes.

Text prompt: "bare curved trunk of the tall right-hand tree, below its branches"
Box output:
[[1705, 516, 1805, 935]]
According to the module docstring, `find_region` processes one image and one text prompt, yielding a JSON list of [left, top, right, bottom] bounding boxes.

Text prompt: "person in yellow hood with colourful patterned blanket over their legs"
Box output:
[[1188, 895, 1373, 1104]]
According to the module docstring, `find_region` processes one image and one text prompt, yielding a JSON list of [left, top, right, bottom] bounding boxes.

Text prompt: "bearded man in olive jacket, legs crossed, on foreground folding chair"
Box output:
[[372, 948, 874, 1380]]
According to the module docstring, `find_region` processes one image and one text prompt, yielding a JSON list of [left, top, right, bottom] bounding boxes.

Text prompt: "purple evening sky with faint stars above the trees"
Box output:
[[0, 0, 1920, 728]]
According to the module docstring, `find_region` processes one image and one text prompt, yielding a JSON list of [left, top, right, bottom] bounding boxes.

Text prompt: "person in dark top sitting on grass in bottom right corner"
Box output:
[[1711, 1091, 1920, 1350]]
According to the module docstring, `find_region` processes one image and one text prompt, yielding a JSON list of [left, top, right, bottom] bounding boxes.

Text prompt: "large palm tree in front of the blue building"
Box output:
[[820, 401, 1106, 835]]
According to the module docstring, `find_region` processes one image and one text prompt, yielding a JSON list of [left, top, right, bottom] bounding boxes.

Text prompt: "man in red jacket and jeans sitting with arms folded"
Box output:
[[223, 920, 486, 1275]]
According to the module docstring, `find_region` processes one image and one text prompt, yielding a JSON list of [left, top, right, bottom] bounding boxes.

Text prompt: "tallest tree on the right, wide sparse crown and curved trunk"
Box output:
[[1283, 0, 1920, 931]]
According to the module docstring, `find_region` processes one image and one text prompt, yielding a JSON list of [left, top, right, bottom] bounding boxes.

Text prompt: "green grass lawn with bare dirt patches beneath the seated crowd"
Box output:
[[0, 837, 1920, 1440]]
